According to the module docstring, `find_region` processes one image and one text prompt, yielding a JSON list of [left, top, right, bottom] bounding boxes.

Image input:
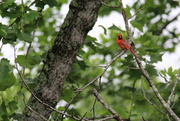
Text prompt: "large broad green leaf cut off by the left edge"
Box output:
[[0, 59, 16, 91]]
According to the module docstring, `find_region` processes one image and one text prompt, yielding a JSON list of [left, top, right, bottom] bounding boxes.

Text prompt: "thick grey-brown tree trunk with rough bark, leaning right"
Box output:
[[23, 0, 101, 121]]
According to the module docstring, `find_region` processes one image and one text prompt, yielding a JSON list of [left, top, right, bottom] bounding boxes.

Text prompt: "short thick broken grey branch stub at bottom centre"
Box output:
[[92, 89, 123, 121]]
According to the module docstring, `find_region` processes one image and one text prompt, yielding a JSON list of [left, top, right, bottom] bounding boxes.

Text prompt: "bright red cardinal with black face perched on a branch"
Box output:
[[116, 34, 138, 58]]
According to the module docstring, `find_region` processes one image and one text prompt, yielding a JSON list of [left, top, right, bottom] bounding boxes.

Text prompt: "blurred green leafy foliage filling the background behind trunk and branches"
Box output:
[[0, 0, 180, 121]]
